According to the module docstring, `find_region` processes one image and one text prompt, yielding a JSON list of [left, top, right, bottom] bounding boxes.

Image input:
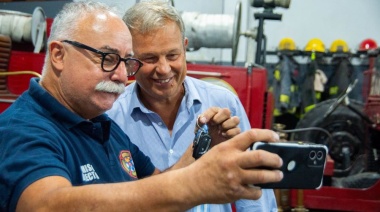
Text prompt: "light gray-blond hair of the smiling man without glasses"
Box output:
[[123, 0, 185, 39]]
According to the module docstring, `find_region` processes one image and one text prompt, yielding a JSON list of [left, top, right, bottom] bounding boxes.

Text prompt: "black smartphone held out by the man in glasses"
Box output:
[[253, 141, 328, 189]]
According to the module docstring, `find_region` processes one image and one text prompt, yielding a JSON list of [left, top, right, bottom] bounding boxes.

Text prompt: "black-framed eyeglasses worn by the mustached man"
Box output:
[[62, 40, 143, 77]]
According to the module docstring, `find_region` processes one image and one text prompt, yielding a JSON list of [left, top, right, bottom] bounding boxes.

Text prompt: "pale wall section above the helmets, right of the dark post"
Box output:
[[265, 0, 380, 62]]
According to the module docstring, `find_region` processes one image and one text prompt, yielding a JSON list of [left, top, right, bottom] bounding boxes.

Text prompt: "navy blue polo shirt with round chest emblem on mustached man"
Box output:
[[0, 79, 155, 211]]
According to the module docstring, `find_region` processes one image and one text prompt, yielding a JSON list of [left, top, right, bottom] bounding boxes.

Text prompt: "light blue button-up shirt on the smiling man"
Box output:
[[107, 76, 277, 212]]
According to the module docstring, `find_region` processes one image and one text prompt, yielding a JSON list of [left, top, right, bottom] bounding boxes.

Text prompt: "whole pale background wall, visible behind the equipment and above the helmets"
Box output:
[[93, 0, 380, 63]]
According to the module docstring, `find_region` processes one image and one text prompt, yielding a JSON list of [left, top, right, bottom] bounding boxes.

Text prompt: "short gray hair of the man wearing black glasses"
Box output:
[[42, 1, 117, 75]]
